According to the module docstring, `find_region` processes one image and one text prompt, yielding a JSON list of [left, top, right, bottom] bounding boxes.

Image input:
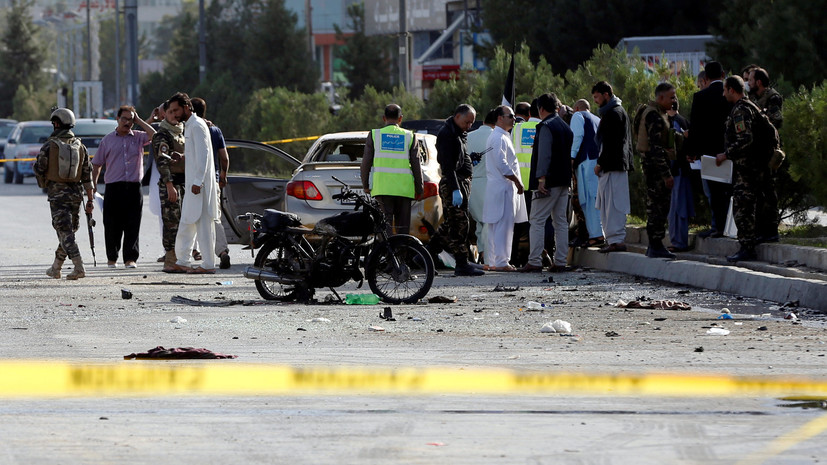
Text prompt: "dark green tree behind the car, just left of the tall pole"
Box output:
[[333, 2, 394, 99]]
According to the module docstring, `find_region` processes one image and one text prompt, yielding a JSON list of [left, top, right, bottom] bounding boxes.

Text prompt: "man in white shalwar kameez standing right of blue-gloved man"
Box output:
[[482, 105, 528, 271]]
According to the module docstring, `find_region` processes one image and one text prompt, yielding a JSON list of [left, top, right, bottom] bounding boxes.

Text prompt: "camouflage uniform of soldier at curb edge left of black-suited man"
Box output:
[[640, 102, 675, 243]]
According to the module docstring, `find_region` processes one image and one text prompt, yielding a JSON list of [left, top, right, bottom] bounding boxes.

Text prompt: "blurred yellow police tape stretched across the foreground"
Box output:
[[0, 361, 827, 399]]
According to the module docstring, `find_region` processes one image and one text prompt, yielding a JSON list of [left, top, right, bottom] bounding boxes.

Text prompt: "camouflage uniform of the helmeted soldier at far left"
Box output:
[[34, 129, 92, 272]]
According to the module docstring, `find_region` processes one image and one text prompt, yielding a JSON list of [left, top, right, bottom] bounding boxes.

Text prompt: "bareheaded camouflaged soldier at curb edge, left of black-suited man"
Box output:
[[637, 83, 677, 258]]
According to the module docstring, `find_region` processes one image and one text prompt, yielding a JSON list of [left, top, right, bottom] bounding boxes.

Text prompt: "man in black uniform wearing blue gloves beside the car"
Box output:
[[428, 103, 485, 276]]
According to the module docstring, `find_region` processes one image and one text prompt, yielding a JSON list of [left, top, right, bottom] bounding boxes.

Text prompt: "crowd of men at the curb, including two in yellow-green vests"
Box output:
[[362, 62, 782, 276]]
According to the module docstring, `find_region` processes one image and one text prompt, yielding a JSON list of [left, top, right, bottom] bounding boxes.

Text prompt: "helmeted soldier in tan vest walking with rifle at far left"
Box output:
[[34, 108, 95, 280]]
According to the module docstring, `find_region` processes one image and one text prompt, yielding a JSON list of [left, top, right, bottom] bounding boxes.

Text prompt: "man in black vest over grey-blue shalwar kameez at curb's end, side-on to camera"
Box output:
[[592, 81, 634, 253]]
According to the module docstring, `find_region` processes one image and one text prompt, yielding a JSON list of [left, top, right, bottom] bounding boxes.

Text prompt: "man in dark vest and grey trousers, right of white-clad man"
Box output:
[[520, 94, 574, 272]]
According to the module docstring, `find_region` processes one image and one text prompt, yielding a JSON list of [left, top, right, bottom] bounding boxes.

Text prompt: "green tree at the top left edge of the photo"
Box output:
[[0, 0, 46, 115]]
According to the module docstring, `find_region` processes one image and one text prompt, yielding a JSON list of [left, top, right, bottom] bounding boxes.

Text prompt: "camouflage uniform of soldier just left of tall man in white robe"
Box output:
[[152, 121, 186, 253]]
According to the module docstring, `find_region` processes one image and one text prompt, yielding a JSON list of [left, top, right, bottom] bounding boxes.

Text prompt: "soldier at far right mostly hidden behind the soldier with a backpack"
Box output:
[[749, 68, 784, 242]]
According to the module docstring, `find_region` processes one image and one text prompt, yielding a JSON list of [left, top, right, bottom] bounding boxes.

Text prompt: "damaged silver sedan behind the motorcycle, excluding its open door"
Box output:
[[286, 131, 442, 243]]
